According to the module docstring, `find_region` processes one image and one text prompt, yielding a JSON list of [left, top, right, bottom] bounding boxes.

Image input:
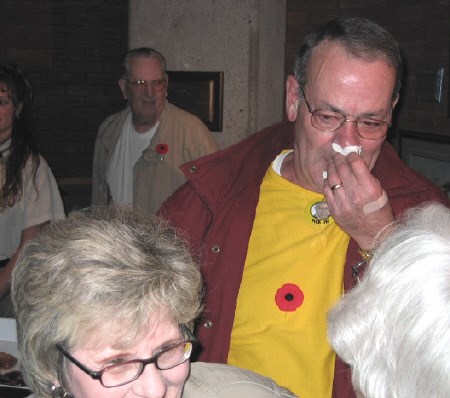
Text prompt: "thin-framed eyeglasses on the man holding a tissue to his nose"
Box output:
[[301, 88, 392, 140]]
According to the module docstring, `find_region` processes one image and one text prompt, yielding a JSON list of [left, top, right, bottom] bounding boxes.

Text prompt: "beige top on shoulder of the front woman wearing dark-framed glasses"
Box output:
[[183, 362, 296, 398]]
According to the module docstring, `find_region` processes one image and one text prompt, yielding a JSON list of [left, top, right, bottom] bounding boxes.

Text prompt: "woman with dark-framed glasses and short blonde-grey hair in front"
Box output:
[[12, 207, 294, 398]]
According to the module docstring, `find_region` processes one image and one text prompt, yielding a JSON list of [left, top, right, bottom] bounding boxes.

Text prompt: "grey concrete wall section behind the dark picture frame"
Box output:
[[129, 0, 286, 147]]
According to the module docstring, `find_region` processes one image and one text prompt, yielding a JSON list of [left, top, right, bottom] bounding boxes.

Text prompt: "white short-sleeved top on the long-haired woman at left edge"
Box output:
[[0, 148, 65, 259]]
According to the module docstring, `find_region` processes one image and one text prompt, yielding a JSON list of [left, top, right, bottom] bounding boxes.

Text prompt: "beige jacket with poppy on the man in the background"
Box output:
[[92, 102, 217, 213]]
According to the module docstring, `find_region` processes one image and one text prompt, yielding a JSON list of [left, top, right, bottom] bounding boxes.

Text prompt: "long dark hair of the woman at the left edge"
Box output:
[[0, 64, 40, 212]]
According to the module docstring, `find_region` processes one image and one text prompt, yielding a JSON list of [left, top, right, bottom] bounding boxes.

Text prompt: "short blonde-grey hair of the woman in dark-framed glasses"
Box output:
[[12, 207, 202, 397]]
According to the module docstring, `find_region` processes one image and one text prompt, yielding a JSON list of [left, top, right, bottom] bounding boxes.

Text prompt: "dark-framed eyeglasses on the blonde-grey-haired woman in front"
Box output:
[[56, 325, 196, 388]]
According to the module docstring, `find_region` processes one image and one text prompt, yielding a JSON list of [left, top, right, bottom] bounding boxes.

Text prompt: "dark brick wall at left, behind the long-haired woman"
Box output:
[[0, 0, 128, 178]]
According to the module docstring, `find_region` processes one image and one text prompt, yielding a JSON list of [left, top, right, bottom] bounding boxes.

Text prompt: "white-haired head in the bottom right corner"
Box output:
[[328, 204, 450, 398]]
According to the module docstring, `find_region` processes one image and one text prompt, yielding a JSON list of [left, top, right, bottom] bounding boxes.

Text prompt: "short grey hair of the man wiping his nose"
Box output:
[[294, 17, 403, 100]]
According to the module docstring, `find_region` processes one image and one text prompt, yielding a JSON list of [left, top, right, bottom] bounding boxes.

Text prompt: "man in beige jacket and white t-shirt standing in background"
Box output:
[[92, 47, 217, 213]]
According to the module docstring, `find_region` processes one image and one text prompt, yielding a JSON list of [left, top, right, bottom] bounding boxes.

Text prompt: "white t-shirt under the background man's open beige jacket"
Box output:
[[106, 113, 159, 204]]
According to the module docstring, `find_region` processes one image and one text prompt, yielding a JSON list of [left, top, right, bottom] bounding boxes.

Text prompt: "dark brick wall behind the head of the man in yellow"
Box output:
[[286, 0, 450, 141]]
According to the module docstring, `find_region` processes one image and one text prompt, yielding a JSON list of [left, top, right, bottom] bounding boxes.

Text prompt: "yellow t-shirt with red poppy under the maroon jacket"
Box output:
[[228, 151, 349, 398]]
